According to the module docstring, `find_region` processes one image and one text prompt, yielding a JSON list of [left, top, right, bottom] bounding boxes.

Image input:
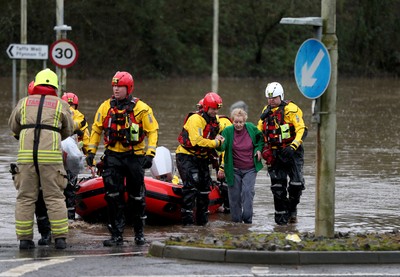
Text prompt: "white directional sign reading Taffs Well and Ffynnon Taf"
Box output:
[[6, 43, 49, 60]]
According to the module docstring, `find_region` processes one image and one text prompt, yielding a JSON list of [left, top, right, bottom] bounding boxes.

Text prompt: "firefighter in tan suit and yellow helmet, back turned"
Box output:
[[8, 69, 73, 249]]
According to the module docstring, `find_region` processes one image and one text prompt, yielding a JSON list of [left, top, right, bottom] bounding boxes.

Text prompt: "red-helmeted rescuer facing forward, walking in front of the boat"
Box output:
[[86, 71, 158, 246]]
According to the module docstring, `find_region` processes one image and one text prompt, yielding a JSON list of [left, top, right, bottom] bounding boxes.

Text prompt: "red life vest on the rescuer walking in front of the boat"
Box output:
[[103, 96, 145, 147]]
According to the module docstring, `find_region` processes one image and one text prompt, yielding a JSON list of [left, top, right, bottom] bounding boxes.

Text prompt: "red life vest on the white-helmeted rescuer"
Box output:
[[261, 101, 296, 148]]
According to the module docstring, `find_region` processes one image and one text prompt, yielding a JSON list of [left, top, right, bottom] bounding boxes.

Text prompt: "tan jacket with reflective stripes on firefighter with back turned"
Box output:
[[8, 95, 74, 164]]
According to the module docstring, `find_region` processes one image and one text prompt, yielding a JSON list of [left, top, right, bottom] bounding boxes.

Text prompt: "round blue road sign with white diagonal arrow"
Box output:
[[294, 39, 331, 99]]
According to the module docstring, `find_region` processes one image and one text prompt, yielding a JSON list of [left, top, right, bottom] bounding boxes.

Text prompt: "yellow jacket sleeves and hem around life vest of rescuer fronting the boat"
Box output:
[[88, 99, 158, 156]]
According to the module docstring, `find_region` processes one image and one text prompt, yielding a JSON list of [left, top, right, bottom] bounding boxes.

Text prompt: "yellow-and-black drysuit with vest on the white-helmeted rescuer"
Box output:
[[257, 101, 307, 225]]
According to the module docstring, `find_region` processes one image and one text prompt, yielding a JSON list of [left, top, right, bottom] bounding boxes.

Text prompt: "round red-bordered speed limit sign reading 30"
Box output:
[[50, 39, 78, 68]]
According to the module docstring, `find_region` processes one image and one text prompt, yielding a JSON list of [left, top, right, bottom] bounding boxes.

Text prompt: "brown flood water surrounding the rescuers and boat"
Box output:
[[0, 77, 400, 245]]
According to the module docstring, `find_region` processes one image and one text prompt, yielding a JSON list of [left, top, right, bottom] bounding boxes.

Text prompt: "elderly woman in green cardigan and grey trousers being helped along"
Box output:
[[218, 108, 264, 224]]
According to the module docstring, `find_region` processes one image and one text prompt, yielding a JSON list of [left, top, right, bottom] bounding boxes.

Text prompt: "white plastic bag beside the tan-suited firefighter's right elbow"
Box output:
[[61, 135, 85, 175]]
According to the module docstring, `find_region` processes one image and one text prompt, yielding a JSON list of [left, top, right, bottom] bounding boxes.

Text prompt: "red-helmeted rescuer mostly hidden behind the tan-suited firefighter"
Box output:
[[61, 92, 90, 220]]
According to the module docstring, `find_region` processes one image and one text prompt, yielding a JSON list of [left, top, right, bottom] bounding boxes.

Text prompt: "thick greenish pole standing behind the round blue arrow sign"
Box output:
[[315, 0, 338, 237]]
